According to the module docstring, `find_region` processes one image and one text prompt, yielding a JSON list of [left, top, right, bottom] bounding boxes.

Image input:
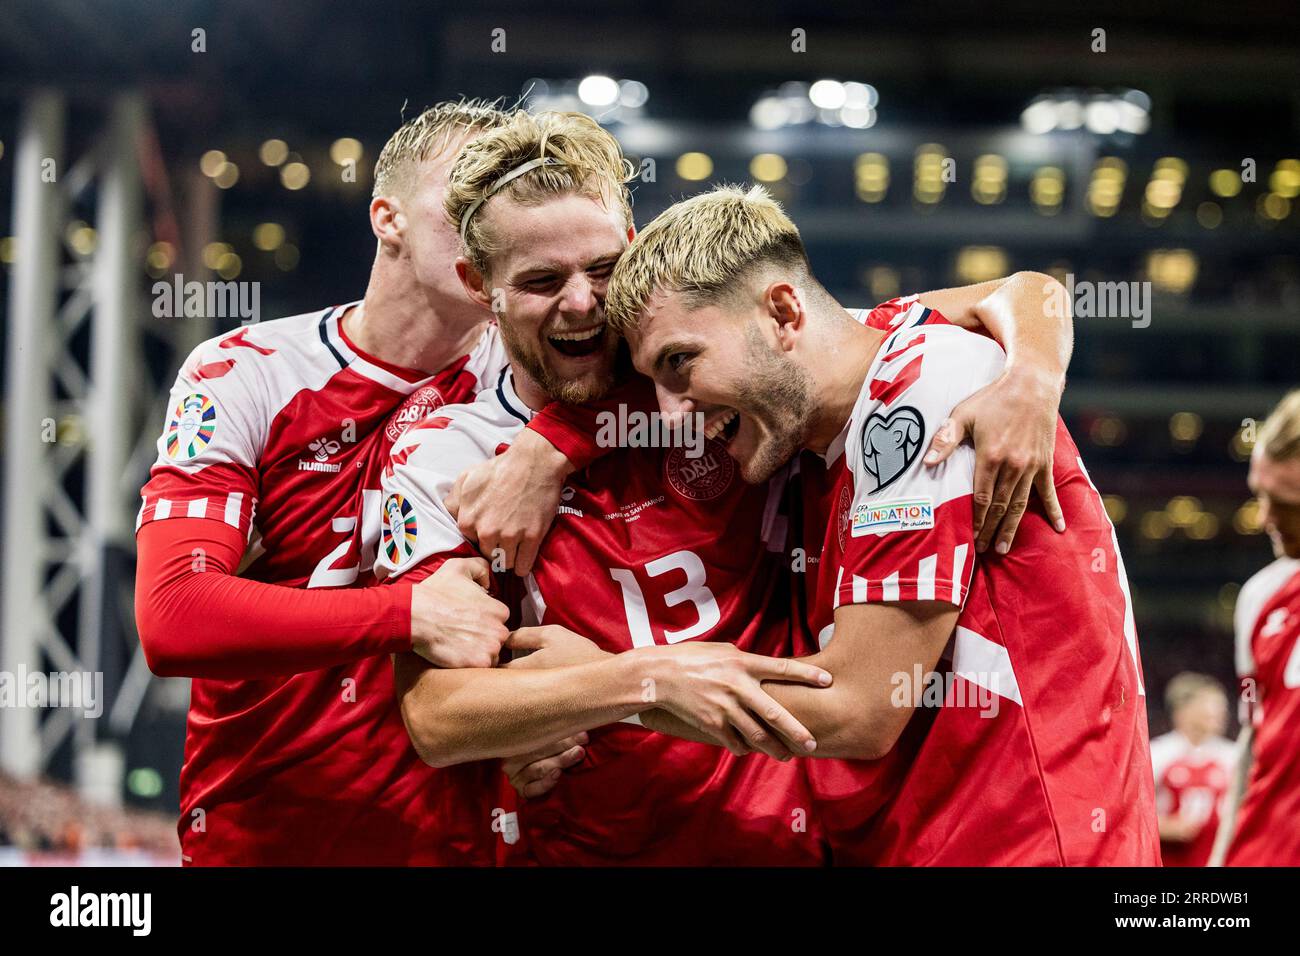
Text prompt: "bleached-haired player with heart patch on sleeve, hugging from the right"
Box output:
[[606, 187, 1160, 866]]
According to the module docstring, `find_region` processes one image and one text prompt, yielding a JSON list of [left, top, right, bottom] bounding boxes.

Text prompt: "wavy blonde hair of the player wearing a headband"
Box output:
[[443, 109, 633, 272]]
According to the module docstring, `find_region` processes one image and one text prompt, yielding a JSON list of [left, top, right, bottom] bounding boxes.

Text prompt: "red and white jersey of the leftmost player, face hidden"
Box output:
[[139, 303, 504, 864]]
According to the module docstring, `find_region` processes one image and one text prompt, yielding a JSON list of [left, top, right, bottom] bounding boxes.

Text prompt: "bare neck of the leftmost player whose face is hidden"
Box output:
[[343, 251, 489, 375]]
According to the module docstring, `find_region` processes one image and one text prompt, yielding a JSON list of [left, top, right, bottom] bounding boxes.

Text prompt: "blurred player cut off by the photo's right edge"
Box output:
[[1225, 390, 1300, 866]]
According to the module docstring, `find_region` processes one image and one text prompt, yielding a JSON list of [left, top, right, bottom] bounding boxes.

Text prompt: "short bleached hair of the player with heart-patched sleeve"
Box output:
[[605, 186, 809, 329]]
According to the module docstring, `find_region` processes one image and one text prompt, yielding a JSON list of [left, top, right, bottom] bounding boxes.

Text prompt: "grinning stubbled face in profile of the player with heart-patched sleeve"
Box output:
[[627, 293, 813, 484]]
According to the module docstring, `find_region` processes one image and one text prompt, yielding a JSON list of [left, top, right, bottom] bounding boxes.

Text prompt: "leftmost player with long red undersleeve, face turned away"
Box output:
[[135, 100, 595, 865]]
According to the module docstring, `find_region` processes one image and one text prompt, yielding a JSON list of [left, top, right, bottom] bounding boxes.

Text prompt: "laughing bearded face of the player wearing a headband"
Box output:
[[473, 194, 629, 403]]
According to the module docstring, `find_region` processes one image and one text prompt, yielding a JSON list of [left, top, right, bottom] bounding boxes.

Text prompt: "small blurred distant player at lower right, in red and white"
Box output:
[[1151, 672, 1236, 866]]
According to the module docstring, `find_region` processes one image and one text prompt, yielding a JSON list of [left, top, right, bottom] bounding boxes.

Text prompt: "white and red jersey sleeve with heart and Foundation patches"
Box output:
[[835, 302, 1006, 606]]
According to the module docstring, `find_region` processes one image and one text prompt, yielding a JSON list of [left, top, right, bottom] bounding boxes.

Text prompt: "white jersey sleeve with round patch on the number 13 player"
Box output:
[[374, 369, 530, 580]]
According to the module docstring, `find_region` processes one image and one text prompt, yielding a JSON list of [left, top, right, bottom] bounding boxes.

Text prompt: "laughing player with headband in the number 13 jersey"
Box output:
[[386, 114, 1081, 862]]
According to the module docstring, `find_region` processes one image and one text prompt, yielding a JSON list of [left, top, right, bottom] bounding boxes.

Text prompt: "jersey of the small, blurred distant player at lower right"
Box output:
[[1151, 731, 1236, 866]]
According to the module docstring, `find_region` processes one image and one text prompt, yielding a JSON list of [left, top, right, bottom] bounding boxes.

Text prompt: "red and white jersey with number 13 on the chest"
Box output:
[[378, 372, 823, 865]]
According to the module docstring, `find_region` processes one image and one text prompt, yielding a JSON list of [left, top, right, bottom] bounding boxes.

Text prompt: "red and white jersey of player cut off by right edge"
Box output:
[[1226, 558, 1300, 866]]
